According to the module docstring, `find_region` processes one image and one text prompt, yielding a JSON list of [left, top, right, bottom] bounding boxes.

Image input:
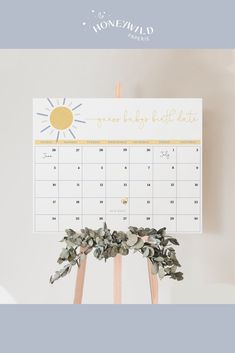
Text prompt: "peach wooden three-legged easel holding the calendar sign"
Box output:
[[73, 82, 158, 304]]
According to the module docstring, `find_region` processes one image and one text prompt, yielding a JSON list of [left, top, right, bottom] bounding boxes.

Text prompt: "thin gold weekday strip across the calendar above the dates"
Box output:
[[34, 140, 201, 145]]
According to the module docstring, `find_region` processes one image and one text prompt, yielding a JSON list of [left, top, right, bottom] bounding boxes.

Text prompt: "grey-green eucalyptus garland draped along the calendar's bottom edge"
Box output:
[[50, 223, 183, 283]]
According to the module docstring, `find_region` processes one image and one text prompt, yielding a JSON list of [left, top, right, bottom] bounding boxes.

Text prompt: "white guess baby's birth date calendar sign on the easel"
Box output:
[[33, 98, 202, 233]]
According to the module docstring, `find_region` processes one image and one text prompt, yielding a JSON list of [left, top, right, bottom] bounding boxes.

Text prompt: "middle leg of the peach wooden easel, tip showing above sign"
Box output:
[[113, 82, 122, 304]]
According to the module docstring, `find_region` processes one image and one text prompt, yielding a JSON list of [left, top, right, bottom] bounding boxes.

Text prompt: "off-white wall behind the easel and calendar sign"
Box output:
[[0, 50, 235, 303]]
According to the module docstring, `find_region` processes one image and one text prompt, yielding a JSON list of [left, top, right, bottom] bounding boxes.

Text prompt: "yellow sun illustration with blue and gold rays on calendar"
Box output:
[[37, 98, 85, 141]]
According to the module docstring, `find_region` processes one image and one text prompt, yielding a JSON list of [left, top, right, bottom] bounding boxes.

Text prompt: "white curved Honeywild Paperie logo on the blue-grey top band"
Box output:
[[82, 10, 154, 41]]
